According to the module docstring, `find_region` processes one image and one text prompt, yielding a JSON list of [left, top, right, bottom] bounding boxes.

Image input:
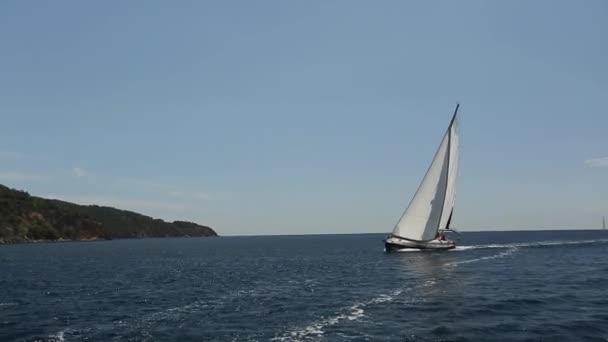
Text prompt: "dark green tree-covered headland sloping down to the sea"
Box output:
[[0, 184, 217, 244]]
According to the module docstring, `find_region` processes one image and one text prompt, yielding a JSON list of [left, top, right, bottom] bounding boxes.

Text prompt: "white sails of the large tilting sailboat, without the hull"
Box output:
[[393, 107, 458, 241]]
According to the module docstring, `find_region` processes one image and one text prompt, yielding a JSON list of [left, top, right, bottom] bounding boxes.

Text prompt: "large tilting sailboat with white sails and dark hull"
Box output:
[[384, 104, 460, 252]]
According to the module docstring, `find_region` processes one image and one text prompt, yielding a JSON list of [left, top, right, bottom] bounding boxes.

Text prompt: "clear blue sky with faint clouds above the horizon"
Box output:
[[0, 0, 608, 235]]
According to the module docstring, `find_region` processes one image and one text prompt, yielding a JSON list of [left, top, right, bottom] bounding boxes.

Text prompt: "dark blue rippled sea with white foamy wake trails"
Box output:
[[0, 230, 608, 342]]
